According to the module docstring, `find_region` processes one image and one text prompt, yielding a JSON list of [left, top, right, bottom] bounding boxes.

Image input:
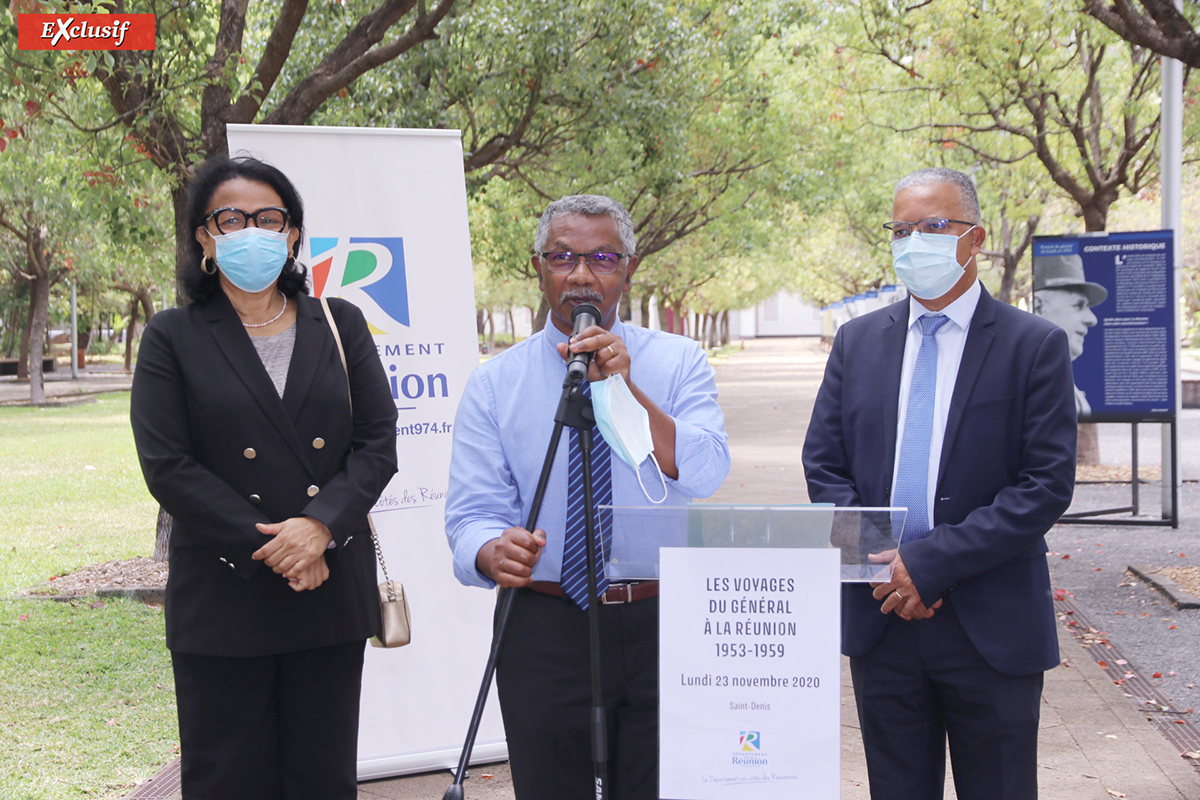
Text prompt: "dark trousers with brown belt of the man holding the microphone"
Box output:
[[496, 589, 659, 800]]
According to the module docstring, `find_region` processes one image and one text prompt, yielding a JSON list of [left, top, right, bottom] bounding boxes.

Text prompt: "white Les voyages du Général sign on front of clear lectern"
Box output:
[[659, 547, 841, 800]]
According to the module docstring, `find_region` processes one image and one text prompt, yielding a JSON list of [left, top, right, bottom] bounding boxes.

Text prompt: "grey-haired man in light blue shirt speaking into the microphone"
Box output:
[[446, 196, 730, 800]]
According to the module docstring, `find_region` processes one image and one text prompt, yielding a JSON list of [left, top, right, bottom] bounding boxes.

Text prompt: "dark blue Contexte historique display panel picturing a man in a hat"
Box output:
[[1032, 230, 1176, 422]]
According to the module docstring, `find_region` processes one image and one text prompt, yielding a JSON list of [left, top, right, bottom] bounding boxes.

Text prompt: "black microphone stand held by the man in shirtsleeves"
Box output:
[[442, 372, 608, 800]]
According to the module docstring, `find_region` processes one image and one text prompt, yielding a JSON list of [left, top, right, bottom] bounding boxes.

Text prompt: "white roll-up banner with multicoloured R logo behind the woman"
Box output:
[[228, 125, 508, 780]]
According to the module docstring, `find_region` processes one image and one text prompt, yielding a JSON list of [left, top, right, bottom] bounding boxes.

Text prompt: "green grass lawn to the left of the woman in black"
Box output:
[[0, 393, 179, 800]]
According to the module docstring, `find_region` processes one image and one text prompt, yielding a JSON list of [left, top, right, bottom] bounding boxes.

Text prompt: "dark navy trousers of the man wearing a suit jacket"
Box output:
[[850, 602, 1043, 800]]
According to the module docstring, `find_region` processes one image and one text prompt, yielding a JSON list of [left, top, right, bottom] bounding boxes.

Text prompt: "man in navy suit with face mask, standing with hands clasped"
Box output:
[[804, 169, 1075, 800]]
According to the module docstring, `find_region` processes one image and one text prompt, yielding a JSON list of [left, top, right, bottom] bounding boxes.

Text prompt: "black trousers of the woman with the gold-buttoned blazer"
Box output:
[[172, 642, 366, 800]]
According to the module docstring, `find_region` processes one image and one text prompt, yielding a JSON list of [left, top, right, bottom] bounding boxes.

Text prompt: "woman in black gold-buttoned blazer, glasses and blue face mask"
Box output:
[[131, 158, 396, 800]]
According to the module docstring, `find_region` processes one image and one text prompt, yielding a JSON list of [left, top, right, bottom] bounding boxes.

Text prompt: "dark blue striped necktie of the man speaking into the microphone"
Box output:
[[559, 381, 612, 610]]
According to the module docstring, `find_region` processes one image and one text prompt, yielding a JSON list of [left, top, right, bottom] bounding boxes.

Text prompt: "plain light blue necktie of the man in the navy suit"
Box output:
[[892, 314, 949, 542]]
